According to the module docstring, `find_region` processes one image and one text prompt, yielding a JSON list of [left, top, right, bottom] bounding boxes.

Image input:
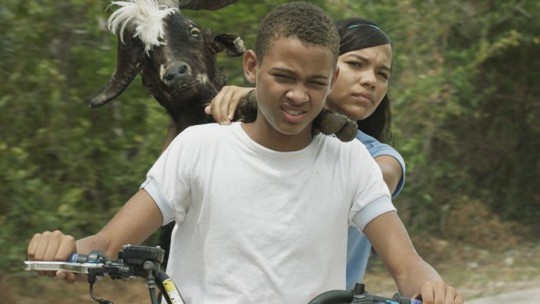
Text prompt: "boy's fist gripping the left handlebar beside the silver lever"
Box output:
[[26, 230, 77, 282]]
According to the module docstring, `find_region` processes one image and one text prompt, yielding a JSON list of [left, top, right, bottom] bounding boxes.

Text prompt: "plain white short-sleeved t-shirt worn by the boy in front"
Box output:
[[142, 123, 395, 304]]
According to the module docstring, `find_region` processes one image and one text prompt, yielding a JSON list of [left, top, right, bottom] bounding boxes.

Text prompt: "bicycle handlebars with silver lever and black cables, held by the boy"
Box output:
[[24, 245, 422, 304]]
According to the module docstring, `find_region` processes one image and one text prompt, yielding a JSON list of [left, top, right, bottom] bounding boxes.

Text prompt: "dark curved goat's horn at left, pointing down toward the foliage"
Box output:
[[89, 35, 144, 108]]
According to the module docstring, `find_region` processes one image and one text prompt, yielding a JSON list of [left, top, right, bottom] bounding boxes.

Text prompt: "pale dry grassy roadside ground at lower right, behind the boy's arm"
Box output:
[[364, 238, 540, 300]]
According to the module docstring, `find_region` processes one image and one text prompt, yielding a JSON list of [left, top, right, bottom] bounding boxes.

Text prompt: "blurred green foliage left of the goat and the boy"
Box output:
[[0, 0, 167, 269]]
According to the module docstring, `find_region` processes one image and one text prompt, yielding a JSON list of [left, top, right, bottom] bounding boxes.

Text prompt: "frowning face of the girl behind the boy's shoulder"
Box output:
[[326, 44, 392, 121]]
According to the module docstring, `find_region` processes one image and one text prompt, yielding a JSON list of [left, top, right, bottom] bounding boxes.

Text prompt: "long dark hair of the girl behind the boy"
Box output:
[[336, 18, 392, 142]]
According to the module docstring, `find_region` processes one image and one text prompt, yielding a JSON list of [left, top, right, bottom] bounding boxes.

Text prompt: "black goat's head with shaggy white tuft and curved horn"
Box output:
[[90, 0, 245, 128]]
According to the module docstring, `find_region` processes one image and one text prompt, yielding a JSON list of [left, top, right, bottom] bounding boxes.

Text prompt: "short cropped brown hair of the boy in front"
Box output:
[[255, 1, 339, 63]]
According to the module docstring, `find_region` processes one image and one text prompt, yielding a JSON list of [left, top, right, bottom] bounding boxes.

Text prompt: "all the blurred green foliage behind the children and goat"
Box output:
[[0, 0, 540, 270]]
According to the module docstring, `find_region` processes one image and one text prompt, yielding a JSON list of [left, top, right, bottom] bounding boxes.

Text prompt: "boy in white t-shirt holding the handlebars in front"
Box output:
[[28, 2, 462, 304]]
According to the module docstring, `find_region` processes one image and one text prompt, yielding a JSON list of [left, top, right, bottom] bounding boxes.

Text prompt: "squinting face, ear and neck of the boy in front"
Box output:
[[244, 38, 337, 151]]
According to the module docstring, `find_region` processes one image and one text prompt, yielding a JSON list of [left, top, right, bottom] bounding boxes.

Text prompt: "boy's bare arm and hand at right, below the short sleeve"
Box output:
[[364, 212, 463, 304]]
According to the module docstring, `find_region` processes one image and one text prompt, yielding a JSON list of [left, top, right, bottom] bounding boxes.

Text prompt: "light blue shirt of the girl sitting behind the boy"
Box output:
[[347, 131, 405, 289]]
